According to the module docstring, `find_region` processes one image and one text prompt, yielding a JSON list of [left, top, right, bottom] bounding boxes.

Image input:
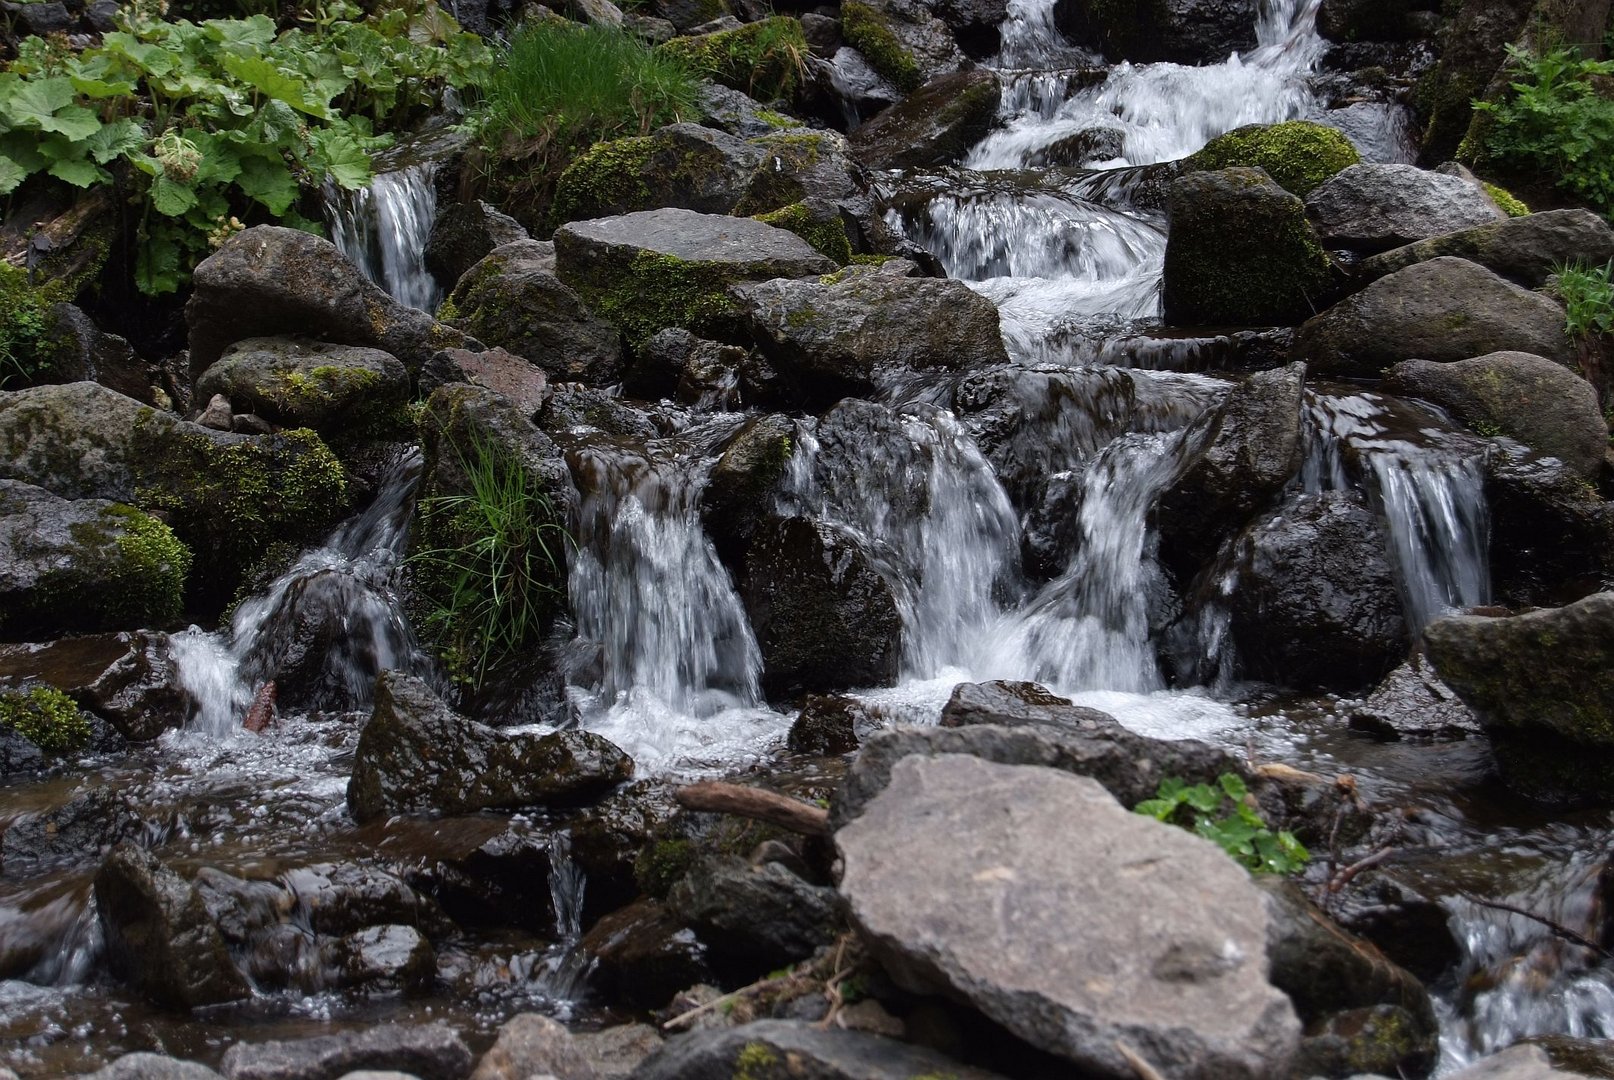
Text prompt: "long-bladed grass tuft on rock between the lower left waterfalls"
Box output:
[[408, 439, 571, 689]]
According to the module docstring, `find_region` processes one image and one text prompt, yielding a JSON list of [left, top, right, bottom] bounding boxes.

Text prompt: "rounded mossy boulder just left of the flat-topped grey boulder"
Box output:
[[439, 241, 623, 386]]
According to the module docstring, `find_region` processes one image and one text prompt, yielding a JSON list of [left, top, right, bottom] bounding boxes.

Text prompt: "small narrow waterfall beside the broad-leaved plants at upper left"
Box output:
[[324, 161, 442, 312]]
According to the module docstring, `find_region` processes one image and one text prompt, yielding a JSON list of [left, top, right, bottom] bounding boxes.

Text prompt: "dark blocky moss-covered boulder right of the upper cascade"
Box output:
[[1162, 168, 1333, 326]]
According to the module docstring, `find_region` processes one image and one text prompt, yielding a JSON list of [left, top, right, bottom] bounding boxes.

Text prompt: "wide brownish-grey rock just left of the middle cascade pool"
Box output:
[[734, 270, 1007, 408]]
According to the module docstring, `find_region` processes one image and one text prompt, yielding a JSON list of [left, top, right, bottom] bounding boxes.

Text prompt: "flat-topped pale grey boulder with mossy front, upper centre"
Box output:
[[555, 208, 836, 345]]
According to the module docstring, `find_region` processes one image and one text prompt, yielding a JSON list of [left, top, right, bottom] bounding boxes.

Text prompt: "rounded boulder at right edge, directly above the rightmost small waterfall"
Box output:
[[1385, 352, 1609, 481]]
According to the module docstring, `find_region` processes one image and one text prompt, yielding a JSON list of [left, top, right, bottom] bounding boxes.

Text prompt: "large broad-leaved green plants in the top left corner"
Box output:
[[0, 0, 487, 295]]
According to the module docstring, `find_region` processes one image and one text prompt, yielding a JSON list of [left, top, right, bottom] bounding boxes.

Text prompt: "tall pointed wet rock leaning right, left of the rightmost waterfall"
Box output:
[[1154, 363, 1306, 581]]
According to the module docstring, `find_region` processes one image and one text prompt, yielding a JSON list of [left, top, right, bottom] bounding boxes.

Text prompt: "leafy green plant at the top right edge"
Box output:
[[1467, 47, 1614, 216]]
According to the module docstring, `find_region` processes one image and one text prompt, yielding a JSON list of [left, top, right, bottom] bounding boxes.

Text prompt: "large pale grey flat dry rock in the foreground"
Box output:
[[834, 756, 1299, 1080]]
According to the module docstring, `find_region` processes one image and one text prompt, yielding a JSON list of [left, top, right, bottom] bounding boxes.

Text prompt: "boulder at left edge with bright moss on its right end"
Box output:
[[0, 479, 190, 641]]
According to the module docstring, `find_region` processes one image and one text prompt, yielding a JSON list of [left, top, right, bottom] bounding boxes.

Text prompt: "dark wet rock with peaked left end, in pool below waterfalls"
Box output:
[[347, 672, 633, 822]]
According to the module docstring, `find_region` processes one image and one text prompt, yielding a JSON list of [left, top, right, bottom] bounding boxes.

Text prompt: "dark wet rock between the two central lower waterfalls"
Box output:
[[741, 518, 902, 697]]
